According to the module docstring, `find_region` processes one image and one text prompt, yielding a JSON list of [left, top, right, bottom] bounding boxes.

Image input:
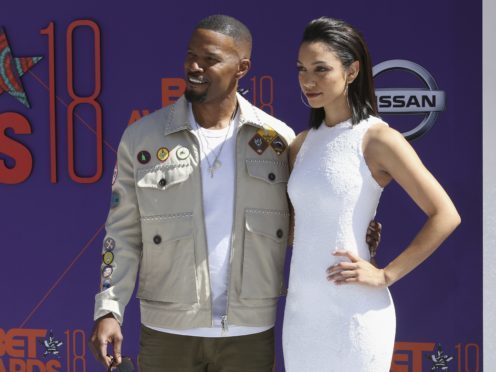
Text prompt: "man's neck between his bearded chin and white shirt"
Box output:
[[192, 94, 237, 129]]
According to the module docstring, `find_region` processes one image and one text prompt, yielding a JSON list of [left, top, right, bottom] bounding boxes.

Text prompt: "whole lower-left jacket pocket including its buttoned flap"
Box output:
[[138, 213, 198, 304]]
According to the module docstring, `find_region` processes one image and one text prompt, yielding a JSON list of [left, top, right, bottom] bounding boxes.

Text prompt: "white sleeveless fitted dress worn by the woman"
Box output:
[[283, 117, 396, 372]]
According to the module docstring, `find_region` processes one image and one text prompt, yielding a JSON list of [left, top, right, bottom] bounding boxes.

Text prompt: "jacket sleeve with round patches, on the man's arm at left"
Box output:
[[94, 126, 142, 324]]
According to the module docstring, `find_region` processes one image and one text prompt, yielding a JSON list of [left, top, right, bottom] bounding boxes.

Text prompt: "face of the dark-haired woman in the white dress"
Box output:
[[297, 42, 349, 108]]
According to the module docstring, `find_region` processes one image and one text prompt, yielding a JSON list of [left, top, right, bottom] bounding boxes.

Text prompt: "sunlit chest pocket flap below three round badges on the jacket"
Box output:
[[136, 164, 193, 190]]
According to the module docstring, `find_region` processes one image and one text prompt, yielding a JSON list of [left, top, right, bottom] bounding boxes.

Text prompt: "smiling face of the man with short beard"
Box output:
[[184, 29, 240, 103]]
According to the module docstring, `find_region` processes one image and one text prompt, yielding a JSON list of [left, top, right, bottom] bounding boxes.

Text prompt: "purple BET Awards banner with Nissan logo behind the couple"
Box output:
[[0, 0, 483, 372]]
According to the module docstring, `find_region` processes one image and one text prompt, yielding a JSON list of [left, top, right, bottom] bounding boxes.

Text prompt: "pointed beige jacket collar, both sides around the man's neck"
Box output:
[[164, 93, 263, 136]]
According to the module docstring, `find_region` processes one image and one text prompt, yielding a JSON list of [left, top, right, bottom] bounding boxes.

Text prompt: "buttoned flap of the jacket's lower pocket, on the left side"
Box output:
[[141, 213, 194, 244]]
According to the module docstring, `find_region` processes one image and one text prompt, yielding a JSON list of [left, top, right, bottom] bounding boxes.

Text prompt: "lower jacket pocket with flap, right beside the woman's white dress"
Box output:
[[240, 209, 289, 299]]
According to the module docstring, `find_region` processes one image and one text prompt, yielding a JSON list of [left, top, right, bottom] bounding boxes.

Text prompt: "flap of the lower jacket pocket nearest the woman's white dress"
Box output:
[[245, 209, 289, 242]]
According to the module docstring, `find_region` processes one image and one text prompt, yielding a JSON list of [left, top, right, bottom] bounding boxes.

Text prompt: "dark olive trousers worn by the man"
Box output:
[[138, 325, 274, 372]]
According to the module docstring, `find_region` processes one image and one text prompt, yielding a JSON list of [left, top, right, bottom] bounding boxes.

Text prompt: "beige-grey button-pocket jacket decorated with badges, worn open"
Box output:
[[94, 94, 294, 329]]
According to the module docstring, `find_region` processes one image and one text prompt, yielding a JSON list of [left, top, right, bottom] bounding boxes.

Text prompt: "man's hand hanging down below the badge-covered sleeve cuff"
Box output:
[[89, 313, 123, 369]]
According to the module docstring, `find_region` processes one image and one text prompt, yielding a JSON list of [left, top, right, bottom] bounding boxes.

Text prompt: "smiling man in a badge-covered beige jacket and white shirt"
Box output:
[[91, 15, 380, 372]]
